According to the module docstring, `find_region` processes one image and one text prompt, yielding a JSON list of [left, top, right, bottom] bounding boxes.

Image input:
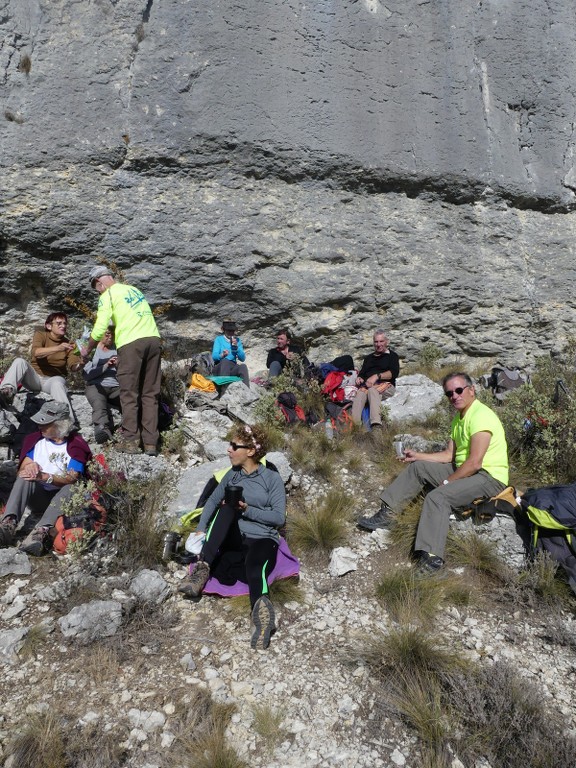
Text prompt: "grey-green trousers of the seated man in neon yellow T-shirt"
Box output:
[[380, 461, 506, 558]]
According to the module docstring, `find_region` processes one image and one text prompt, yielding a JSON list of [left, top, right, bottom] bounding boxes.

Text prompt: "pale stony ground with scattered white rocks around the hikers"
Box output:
[[0, 376, 576, 768]]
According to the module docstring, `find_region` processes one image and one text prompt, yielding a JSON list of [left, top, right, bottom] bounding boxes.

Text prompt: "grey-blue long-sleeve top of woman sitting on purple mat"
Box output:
[[198, 465, 286, 541]]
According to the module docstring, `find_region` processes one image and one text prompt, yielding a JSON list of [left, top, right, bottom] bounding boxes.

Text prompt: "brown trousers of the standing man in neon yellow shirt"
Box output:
[[117, 336, 162, 446]]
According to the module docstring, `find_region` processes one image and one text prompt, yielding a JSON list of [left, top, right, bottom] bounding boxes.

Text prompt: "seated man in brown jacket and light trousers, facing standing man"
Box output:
[[0, 312, 82, 420]]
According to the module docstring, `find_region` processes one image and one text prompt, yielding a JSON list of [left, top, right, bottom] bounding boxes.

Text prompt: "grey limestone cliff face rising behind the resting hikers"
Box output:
[[0, 0, 576, 361]]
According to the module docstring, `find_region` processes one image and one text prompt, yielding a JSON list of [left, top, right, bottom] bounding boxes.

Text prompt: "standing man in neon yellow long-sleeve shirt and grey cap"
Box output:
[[82, 266, 161, 456]]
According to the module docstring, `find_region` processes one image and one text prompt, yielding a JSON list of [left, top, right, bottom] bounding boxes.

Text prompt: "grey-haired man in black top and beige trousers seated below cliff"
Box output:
[[352, 329, 400, 429]]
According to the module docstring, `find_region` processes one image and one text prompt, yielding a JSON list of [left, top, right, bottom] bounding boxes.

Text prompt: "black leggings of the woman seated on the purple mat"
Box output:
[[202, 503, 278, 607]]
